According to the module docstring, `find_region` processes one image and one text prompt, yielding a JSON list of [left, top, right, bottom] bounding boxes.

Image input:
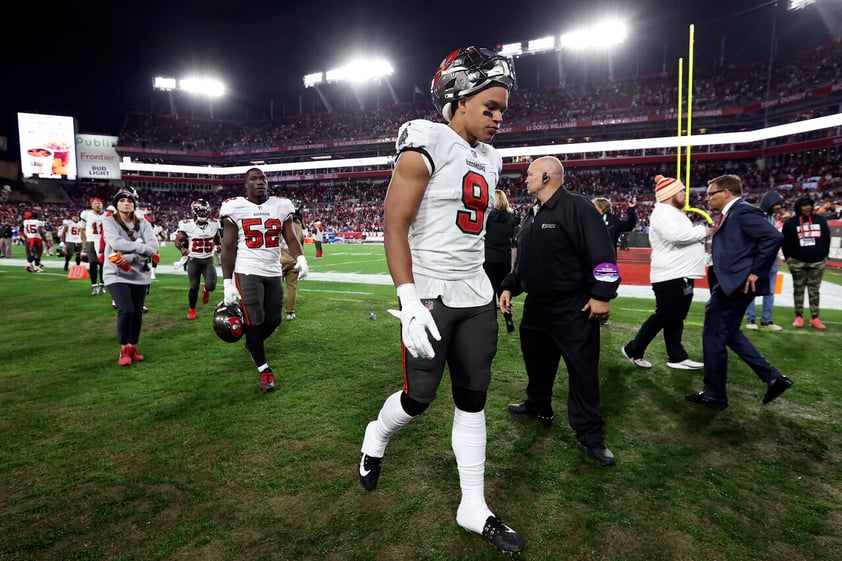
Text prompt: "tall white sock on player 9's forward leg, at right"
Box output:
[[451, 407, 494, 534]]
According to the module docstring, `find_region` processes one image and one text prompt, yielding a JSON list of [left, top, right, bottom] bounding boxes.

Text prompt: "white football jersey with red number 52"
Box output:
[[219, 197, 295, 277]]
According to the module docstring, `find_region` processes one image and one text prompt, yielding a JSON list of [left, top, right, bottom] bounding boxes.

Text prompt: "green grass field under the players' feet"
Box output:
[[0, 245, 842, 561]]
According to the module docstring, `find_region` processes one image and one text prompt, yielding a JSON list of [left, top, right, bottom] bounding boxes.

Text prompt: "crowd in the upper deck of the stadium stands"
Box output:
[[118, 43, 842, 153]]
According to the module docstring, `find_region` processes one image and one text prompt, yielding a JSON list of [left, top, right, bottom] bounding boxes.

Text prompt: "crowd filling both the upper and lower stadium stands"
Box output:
[[0, 43, 842, 246]]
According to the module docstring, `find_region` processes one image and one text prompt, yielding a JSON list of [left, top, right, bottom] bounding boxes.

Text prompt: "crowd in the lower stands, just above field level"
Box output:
[[0, 153, 842, 247]]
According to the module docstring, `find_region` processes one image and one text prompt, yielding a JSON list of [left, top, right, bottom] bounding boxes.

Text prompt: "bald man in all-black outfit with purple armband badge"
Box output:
[[500, 156, 620, 466]]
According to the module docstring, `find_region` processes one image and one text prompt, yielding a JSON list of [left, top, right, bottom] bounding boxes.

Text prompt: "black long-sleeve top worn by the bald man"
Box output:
[[501, 187, 620, 301]]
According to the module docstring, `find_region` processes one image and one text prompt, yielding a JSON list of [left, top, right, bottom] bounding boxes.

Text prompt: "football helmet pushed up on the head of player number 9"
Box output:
[[430, 47, 515, 123]]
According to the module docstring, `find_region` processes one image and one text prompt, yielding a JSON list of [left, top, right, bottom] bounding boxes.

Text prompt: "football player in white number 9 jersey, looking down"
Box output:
[[359, 47, 525, 552]]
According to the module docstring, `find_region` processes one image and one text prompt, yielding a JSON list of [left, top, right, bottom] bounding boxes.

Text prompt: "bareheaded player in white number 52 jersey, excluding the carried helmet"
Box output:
[[219, 168, 310, 392]]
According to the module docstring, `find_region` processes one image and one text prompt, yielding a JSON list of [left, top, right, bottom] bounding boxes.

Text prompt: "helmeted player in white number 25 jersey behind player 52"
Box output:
[[175, 199, 222, 319]]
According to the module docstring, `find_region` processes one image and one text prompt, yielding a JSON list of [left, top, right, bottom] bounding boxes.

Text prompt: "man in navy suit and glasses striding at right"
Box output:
[[686, 175, 792, 408]]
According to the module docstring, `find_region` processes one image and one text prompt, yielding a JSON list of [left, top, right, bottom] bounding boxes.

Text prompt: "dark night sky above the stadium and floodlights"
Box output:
[[0, 0, 831, 160]]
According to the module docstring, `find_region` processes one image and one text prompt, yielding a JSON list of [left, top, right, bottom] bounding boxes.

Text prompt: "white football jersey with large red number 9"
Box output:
[[395, 119, 503, 303]]
